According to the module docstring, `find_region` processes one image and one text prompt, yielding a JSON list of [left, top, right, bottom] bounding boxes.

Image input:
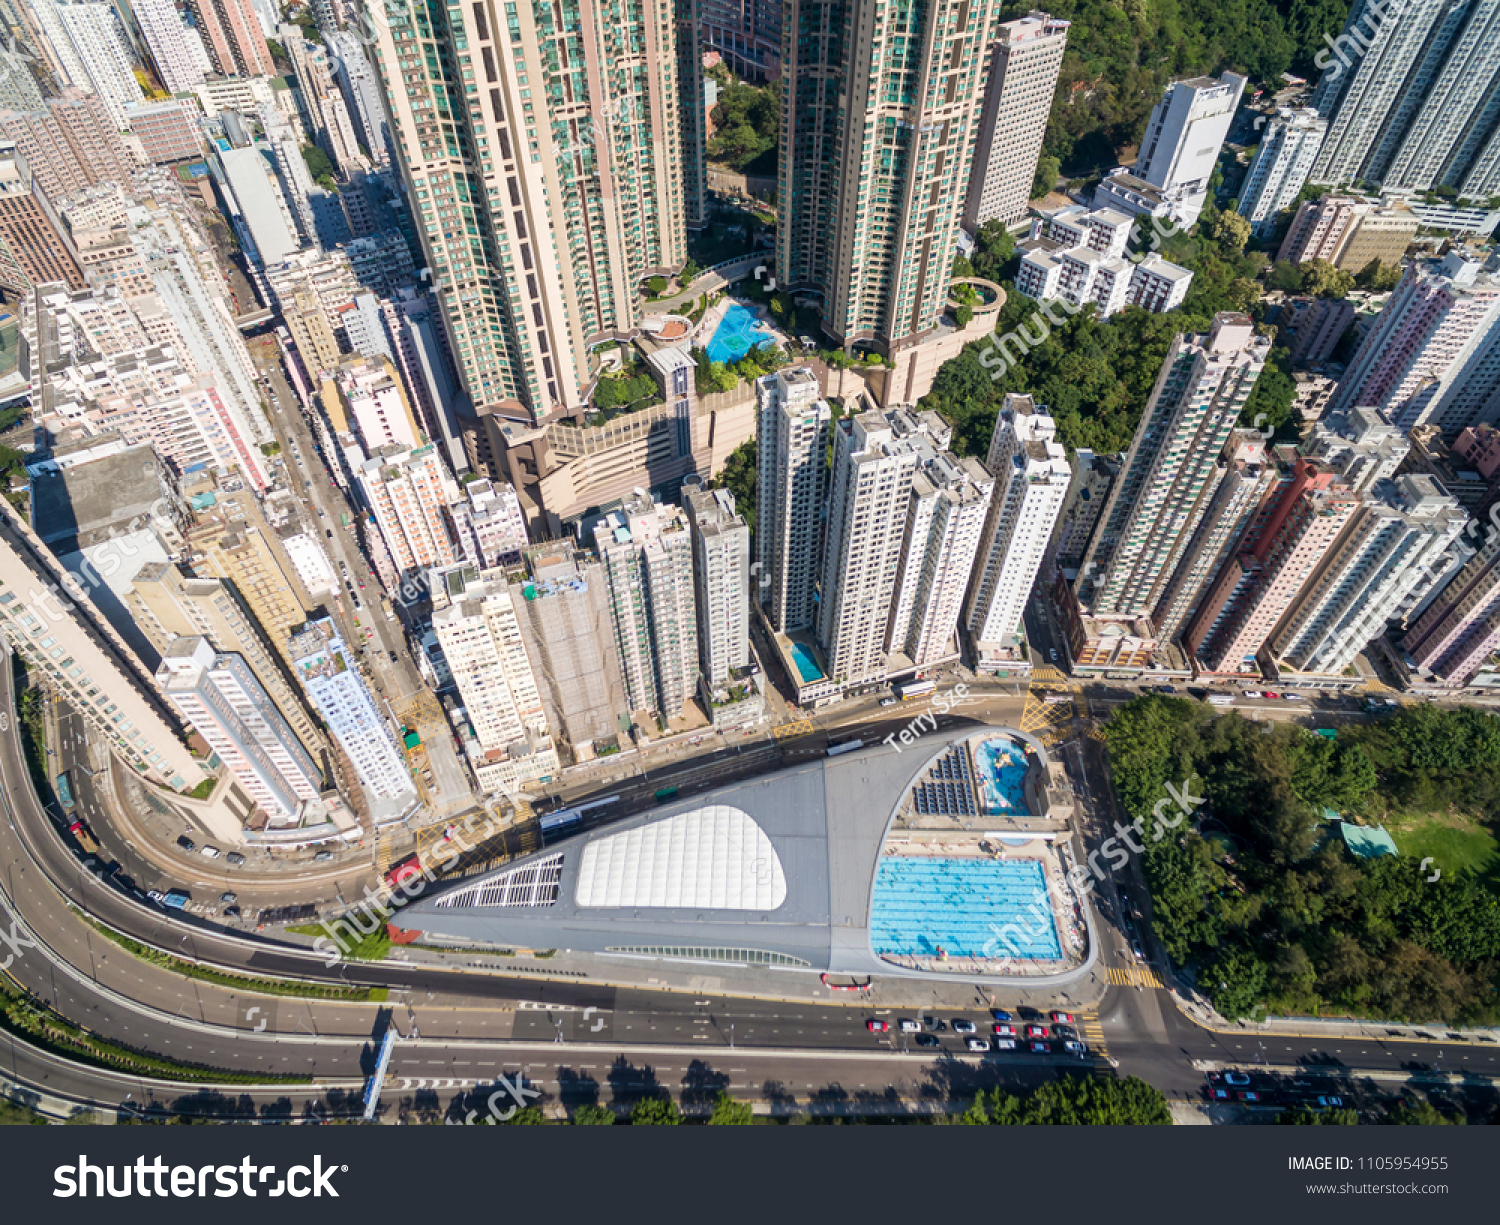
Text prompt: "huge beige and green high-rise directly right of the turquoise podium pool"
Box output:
[[776, 0, 1008, 358]]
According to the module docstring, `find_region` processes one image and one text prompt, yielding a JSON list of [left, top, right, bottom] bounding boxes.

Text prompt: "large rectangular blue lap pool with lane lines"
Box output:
[[870, 856, 1062, 961]]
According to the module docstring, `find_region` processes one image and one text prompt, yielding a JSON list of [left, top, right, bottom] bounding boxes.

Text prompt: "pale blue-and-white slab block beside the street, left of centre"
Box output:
[[287, 618, 417, 816]]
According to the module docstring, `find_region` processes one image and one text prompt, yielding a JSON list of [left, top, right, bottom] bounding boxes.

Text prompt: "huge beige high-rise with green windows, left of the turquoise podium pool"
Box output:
[[363, 0, 690, 424]]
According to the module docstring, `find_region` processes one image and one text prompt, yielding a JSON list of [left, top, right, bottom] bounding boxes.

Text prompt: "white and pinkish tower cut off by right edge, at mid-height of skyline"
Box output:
[[1328, 250, 1500, 438]]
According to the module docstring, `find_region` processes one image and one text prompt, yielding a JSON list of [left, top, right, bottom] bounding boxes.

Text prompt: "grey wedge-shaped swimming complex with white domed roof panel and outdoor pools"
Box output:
[[393, 729, 1095, 985]]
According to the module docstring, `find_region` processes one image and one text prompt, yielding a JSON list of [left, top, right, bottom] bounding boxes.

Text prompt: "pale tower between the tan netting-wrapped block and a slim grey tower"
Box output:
[[594, 490, 698, 720]]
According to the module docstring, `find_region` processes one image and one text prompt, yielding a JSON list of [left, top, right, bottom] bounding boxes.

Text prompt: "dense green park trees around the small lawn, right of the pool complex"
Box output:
[[1106, 696, 1500, 1023]]
